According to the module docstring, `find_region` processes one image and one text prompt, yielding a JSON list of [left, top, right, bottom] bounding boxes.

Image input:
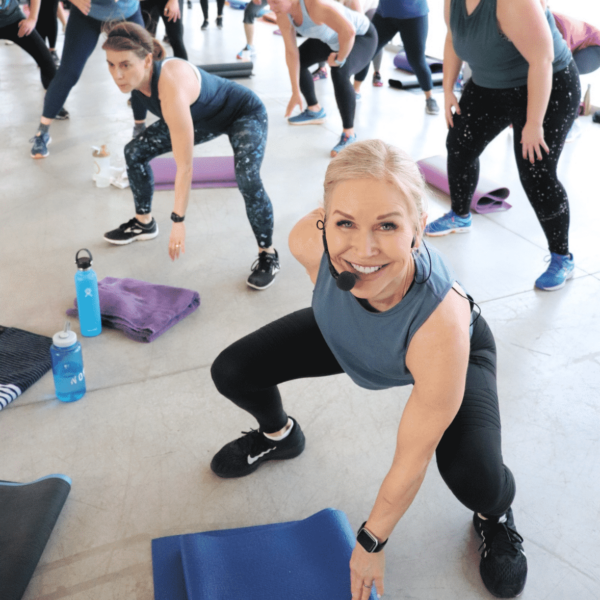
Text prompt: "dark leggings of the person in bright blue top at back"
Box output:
[[354, 13, 433, 92]]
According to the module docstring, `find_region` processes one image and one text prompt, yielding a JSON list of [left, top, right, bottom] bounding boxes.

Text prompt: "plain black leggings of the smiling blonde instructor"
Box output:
[[211, 308, 515, 516]]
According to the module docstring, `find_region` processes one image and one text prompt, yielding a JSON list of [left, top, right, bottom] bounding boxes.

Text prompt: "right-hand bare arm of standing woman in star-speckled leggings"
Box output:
[[497, 0, 554, 163]]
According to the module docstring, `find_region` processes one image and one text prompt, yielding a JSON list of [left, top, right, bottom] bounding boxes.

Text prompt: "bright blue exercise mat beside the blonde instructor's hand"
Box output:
[[152, 508, 376, 600]]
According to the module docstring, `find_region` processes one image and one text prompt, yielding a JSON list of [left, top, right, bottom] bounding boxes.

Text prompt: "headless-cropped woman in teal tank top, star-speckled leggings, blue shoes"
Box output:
[[425, 0, 581, 291]]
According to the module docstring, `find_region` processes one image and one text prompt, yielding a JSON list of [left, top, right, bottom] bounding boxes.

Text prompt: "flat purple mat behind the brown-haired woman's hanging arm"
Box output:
[[150, 156, 237, 190]]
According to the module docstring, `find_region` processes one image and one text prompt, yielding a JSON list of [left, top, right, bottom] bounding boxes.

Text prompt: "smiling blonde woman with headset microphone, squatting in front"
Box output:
[[211, 140, 527, 600]]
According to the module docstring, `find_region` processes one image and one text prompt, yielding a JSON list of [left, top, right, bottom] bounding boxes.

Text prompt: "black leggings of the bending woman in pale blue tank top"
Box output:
[[298, 23, 377, 129]]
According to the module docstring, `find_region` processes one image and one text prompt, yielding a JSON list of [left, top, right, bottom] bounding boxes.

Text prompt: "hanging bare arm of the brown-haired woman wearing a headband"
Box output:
[[158, 60, 200, 260]]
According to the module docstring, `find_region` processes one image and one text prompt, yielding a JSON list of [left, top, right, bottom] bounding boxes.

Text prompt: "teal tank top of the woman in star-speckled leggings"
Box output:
[[450, 0, 572, 89]]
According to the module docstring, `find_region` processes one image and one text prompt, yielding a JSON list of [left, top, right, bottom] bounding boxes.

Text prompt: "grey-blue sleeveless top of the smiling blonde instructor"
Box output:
[[312, 246, 456, 390]]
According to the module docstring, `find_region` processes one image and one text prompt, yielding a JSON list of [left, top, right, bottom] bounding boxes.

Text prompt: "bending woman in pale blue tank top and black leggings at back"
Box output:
[[269, 0, 377, 156]]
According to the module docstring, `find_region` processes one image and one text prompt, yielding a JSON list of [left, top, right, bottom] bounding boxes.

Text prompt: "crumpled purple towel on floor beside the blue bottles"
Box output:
[[67, 277, 200, 342]]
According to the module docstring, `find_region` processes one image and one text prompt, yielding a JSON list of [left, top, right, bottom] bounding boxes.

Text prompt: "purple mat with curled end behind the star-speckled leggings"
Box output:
[[417, 156, 511, 215]]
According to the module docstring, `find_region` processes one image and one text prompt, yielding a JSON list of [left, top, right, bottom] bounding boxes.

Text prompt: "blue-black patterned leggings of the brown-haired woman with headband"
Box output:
[[125, 110, 273, 248]]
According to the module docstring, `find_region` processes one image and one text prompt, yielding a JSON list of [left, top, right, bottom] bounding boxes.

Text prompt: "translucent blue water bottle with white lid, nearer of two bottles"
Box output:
[[50, 321, 85, 402]]
